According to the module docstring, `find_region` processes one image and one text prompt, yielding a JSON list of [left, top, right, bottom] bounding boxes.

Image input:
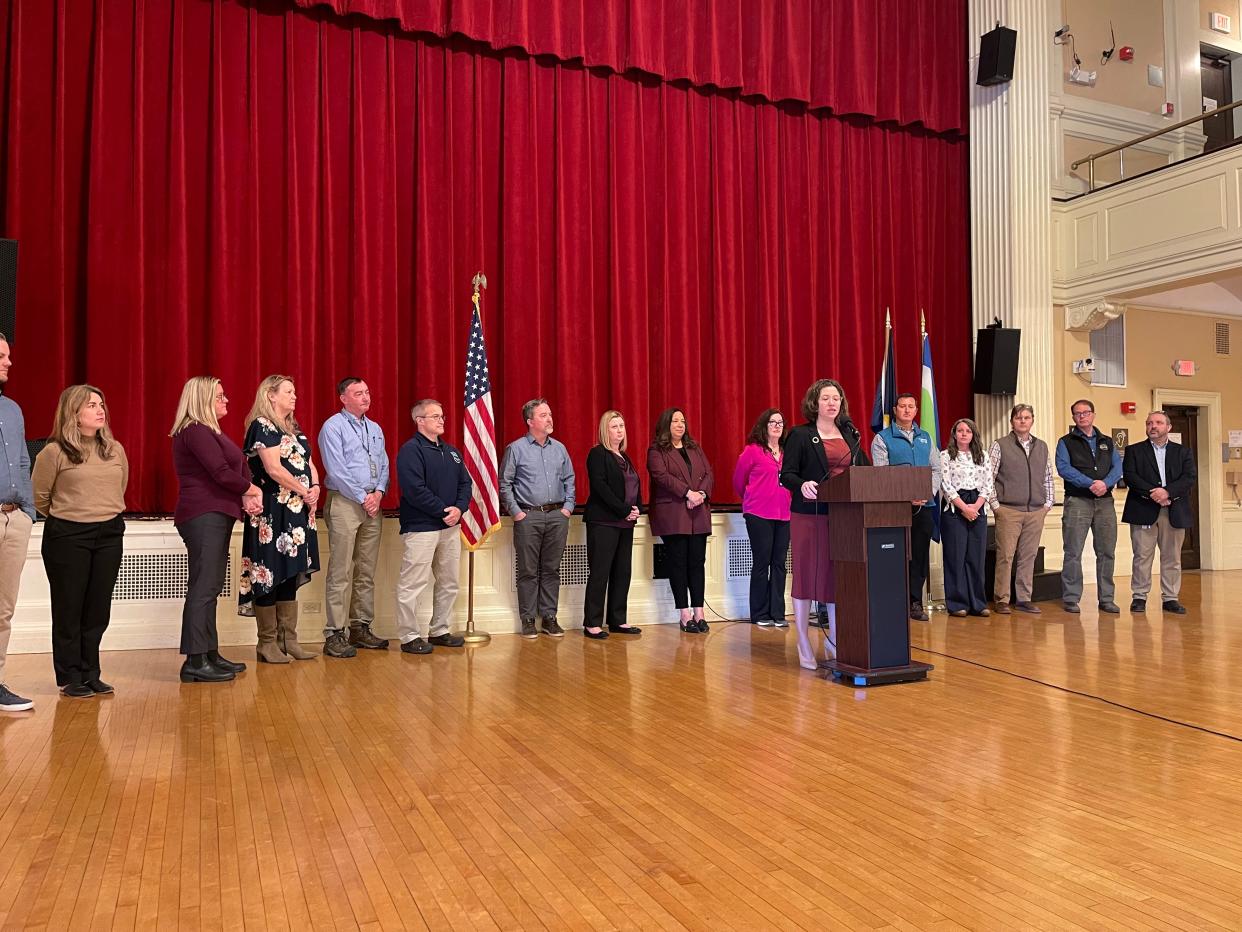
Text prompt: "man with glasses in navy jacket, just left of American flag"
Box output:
[[396, 398, 473, 654]]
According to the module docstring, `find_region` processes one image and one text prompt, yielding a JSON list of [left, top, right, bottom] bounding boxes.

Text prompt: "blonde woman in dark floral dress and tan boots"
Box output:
[[238, 375, 319, 664]]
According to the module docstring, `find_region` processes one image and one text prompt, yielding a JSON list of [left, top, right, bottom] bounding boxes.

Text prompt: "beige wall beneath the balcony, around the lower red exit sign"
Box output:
[[1045, 308, 1242, 508]]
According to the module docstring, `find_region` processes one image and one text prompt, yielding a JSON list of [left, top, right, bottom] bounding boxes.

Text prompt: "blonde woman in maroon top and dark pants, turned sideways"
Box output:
[[169, 375, 262, 682]]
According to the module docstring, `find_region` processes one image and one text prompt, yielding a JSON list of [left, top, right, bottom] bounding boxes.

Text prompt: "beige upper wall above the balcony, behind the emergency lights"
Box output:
[[1061, 0, 1167, 110]]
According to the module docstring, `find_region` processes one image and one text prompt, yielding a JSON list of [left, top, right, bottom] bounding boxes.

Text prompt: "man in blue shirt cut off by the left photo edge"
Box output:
[[0, 333, 35, 712]]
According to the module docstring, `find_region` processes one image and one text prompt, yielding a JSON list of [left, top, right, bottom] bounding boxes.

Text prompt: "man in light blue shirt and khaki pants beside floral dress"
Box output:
[[319, 377, 389, 657]]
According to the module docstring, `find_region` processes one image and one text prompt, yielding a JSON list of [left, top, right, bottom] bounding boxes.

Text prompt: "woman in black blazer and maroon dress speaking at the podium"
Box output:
[[780, 379, 867, 670]]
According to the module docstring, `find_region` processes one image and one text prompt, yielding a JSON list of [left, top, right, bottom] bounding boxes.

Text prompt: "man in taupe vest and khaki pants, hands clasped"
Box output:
[[987, 404, 1052, 615]]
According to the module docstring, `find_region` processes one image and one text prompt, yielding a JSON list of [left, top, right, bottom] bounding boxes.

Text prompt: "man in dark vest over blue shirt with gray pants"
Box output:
[[1057, 398, 1122, 615]]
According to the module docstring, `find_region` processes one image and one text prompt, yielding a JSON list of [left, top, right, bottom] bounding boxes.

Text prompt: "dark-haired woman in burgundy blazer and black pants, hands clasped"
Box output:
[[647, 408, 714, 633]]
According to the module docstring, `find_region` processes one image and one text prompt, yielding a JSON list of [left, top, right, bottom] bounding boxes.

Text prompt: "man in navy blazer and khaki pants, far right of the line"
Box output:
[[1122, 411, 1197, 615]]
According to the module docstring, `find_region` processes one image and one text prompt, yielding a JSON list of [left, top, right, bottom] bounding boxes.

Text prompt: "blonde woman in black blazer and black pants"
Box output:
[[582, 411, 642, 641]]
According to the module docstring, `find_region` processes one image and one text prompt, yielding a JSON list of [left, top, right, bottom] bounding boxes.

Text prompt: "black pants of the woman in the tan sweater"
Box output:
[[42, 514, 125, 686]]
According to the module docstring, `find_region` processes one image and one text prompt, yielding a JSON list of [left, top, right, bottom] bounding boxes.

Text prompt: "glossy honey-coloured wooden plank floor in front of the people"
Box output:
[[0, 572, 1242, 930]]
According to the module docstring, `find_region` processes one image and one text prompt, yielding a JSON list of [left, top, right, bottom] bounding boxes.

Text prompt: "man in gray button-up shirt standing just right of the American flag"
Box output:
[[501, 398, 574, 639]]
